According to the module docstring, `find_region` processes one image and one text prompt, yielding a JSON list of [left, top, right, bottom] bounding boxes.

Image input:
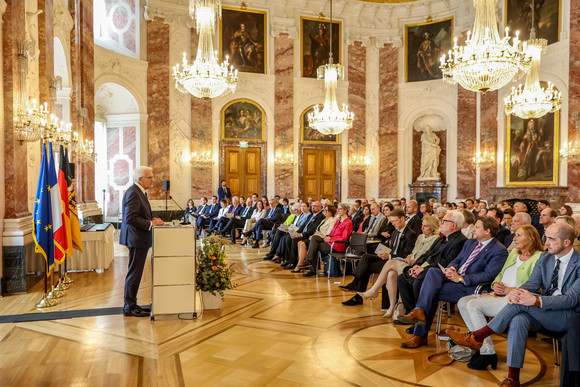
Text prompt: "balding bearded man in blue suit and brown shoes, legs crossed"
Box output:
[[447, 223, 580, 387]]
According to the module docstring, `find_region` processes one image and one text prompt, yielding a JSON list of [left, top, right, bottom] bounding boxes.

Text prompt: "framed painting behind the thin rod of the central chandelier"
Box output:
[[300, 16, 342, 78]]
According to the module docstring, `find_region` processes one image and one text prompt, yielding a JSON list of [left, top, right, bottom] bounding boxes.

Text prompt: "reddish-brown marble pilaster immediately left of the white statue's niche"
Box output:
[[378, 44, 399, 198]]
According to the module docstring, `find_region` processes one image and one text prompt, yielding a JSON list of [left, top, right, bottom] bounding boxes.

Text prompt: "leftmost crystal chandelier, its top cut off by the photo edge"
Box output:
[[173, 0, 238, 99]]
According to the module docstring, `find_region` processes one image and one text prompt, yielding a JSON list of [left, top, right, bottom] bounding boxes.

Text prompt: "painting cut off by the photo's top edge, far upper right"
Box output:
[[505, 0, 562, 44]]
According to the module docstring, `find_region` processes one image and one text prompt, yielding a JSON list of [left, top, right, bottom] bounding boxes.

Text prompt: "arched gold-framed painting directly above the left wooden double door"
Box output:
[[222, 99, 266, 141]]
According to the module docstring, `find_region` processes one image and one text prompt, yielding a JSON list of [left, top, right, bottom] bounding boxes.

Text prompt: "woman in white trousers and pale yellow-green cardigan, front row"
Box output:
[[457, 225, 544, 370]]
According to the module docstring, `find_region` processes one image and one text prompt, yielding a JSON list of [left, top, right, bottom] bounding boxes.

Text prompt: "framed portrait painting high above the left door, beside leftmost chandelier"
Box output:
[[219, 7, 268, 74]]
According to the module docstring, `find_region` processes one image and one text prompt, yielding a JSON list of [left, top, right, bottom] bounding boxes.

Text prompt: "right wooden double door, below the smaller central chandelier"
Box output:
[[302, 149, 337, 200]]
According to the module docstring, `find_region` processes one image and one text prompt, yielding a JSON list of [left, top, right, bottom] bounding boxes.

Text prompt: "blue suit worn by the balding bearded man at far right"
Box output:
[[488, 250, 580, 368]]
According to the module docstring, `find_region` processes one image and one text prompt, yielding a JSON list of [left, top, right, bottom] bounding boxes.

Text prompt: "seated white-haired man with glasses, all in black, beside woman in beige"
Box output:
[[395, 211, 466, 316]]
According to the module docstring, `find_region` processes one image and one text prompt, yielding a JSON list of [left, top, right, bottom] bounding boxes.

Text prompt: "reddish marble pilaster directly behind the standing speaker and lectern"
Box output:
[[147, 18, 170, 199]]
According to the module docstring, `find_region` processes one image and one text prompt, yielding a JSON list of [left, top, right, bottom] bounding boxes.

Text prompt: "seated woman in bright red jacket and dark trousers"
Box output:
[[302, 203, 352, 277]]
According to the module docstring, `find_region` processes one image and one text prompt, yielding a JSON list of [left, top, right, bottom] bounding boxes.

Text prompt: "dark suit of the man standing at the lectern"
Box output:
[[119, 184, 153, 310]]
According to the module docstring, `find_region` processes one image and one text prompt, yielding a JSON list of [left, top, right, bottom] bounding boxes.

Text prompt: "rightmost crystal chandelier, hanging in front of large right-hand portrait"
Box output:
[[504, 2, 562, 119]]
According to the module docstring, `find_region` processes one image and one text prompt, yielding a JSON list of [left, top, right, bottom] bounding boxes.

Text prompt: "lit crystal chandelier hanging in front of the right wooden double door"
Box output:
[[308, 0, 354, 134]]
